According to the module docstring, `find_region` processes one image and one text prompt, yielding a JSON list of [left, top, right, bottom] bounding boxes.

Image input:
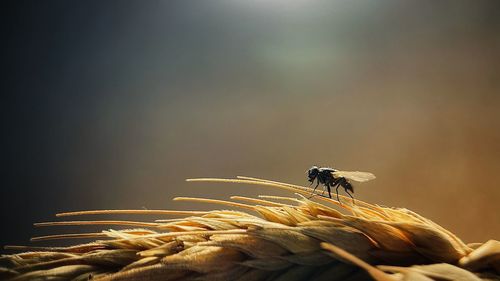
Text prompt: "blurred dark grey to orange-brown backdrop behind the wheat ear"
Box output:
[[0, 0, 500, 245]]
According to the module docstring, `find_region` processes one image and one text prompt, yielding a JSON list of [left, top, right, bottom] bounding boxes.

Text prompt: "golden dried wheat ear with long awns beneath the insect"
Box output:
[[0, 177, 500, 281]]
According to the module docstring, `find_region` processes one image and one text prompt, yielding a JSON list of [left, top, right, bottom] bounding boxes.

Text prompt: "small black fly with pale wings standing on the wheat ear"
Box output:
[[307, 166, 375, 202]]
